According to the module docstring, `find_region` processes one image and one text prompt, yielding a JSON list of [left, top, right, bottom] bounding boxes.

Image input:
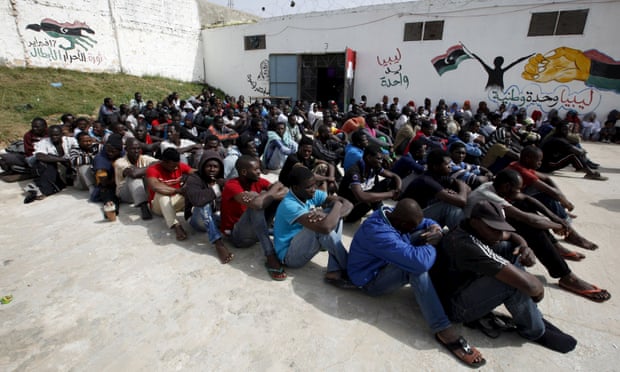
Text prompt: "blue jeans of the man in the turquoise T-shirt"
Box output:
[[283, 220, 349, 272]]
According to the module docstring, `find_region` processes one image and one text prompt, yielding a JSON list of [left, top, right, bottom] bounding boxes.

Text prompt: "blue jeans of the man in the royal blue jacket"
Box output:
[[362, 264, 451, 333]]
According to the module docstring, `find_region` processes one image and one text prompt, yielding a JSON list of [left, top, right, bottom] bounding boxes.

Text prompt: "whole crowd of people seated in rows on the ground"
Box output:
[[1, 89, 620, 367]]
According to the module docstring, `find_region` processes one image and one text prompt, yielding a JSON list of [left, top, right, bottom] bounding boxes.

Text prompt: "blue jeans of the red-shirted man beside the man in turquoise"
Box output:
[[231, 208, 276, 256]]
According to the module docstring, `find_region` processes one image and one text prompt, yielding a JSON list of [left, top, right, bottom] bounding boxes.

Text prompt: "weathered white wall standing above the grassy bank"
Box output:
[[0, 0, 204, 81]]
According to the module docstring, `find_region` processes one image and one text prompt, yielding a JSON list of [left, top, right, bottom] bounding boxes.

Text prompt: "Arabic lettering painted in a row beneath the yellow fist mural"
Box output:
[[488, 84, 602, 113]]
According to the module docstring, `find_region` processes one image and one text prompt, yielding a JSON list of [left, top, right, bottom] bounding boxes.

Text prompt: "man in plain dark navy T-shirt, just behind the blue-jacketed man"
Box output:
[[402, 149, 470, 229]]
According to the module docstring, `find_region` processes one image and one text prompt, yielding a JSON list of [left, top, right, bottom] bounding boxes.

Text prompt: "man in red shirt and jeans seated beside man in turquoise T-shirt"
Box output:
[[220, 155, 288, 280]]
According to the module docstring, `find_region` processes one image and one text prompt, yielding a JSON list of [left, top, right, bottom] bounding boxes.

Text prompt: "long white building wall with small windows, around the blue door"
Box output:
[[203, 0, 620, 117]]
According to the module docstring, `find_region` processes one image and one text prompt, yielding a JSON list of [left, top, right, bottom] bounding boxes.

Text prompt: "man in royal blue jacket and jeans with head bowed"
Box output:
[[348, 199, 485, 367]]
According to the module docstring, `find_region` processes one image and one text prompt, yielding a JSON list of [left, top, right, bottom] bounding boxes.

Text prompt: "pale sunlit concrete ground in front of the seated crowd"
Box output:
[[0, 144, 620, 371]]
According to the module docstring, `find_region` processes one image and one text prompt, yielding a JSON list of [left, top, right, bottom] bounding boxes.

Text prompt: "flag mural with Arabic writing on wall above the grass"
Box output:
[[25, 18, 105, 65]]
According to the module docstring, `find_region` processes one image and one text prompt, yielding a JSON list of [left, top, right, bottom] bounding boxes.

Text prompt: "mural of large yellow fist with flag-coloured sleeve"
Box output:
[[521, 47, 620, 93]]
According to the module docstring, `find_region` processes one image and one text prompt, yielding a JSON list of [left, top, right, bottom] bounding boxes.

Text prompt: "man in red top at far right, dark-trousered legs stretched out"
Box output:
[[508, 146, 598, 250]]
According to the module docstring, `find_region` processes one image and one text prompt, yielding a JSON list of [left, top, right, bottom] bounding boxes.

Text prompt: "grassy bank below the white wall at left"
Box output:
[[0, 67, 209, 148]]
